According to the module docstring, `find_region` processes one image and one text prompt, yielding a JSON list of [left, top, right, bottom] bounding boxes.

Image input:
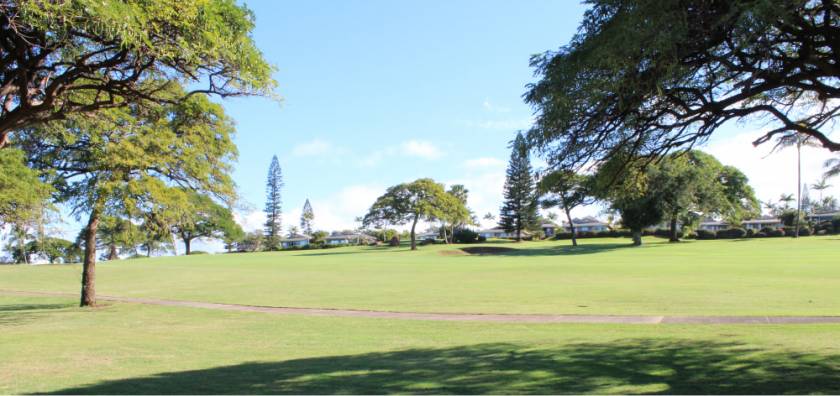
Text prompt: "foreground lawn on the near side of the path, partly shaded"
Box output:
[[0, 296, 840, 394]]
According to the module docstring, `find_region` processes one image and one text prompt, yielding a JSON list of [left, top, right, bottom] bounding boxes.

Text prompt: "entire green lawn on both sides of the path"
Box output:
[[0, 237, 840, 394]]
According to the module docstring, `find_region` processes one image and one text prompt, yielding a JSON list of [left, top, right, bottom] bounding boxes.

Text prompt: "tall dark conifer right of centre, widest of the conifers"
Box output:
[[499, 133, 537, 241]]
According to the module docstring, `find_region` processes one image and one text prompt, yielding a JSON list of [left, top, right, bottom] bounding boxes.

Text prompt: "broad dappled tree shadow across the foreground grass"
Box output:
[[46, 339, 840, 394]]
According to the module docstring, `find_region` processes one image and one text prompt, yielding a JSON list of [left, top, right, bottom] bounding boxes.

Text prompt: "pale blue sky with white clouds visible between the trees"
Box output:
[[18, 0, 840, 256]]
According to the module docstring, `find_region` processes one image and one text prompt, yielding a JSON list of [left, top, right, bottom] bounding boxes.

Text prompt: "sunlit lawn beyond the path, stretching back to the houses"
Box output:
[[0, 237, 840, 315]]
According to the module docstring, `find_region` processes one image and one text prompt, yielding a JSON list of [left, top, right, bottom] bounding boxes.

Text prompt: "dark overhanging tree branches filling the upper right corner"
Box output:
[[525, 0, 840, 173]]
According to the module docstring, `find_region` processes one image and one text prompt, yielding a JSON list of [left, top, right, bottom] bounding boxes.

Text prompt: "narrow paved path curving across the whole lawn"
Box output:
[[0, 290, 840, 324]]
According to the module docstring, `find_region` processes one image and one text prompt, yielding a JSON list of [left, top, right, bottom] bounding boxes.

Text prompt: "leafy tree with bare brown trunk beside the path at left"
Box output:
[[14, 87, 236, 306]]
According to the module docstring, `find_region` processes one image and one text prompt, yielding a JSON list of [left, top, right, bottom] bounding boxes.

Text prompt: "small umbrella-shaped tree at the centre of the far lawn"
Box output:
[[362, 179, 452, 250]]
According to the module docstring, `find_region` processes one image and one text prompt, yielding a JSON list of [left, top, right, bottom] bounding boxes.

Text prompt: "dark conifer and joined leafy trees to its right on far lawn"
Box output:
[[492, 134, 760, 246]]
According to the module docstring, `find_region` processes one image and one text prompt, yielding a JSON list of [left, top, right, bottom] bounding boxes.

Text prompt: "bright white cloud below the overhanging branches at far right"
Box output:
[[701, 131, 840, 207]]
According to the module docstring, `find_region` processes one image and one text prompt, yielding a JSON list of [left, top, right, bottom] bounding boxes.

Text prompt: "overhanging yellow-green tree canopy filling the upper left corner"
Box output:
[[0, 0, 275, 148]]
